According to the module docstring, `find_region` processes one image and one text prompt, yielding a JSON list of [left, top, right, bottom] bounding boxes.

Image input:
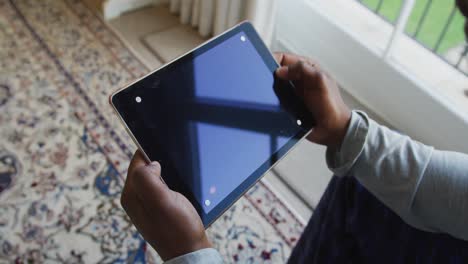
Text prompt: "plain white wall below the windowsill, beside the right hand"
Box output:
[[276, 0, 468, 153]]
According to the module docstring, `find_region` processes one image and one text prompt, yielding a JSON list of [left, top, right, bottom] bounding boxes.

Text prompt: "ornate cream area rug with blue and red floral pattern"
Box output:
[[0, 0, 303, 263]]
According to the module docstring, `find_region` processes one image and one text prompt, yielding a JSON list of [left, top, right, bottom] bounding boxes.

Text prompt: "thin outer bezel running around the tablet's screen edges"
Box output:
[[109, 22, 310, 228]]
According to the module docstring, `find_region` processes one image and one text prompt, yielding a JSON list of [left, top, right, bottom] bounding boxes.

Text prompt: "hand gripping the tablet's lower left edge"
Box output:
[[121, 151, 211, 261]]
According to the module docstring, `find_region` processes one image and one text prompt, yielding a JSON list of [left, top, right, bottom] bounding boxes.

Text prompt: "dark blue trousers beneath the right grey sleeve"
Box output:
[[289, 174, 468, 264]]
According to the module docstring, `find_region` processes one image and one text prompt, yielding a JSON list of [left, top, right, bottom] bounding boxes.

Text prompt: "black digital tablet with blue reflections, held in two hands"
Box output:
[[110, 22, 313, 227]]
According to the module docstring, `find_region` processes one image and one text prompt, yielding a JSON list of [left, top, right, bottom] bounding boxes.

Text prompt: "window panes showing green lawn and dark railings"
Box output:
[[355, 0, 468, 75]]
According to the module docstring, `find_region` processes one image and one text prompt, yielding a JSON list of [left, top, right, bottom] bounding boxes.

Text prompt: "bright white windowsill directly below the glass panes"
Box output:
[[314, 1, 468, 115]]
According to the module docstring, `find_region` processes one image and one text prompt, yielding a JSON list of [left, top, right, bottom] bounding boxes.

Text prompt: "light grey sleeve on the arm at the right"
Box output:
[[327, 111, 468, 240]]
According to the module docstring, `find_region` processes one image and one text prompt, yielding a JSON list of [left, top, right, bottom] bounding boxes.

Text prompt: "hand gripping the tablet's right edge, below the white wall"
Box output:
[[275, 53, 351, 149]]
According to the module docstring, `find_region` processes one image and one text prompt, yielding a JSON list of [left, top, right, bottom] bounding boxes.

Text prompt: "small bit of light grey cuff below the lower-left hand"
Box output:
[[164, 248, 223, 264]]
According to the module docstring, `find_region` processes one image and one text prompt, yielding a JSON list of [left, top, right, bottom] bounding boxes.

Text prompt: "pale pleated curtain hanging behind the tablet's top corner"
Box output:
[[170, 0, 276, 45]]
